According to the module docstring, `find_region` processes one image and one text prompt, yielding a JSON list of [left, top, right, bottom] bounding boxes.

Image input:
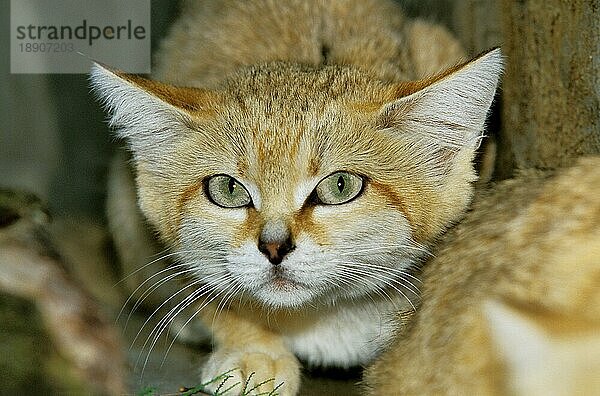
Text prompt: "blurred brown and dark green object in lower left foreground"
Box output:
[[0, 190, 125, 394]]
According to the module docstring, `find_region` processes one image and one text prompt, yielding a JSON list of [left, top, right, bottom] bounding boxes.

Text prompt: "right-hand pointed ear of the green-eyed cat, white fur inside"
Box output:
[[378, 48, 502, 173]]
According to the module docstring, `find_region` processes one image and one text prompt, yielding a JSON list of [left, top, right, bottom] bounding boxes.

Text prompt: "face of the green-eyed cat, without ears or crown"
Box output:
[[166, 74, 427, 306]]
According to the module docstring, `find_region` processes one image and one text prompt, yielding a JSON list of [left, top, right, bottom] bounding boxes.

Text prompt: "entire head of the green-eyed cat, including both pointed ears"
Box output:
[[91, 49, 502, 307]]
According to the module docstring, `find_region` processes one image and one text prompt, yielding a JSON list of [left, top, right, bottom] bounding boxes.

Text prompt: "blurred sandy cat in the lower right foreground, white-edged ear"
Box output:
[[366, 158, 600, 396]]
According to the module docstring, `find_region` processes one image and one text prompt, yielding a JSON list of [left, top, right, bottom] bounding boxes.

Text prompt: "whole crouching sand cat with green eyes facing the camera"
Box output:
[[91, 0, 502, 395]]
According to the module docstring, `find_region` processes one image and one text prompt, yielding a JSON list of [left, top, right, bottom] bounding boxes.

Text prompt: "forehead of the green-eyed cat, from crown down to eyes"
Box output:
[[185, 65, 404, 195]]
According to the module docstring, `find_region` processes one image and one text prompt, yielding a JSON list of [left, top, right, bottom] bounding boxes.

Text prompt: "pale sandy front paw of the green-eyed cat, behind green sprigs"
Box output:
[[202, 349, 300, 396]]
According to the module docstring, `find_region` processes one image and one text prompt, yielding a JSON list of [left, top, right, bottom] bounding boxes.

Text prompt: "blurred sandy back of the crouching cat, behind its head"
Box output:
[[154, 0, 463, 87]]
